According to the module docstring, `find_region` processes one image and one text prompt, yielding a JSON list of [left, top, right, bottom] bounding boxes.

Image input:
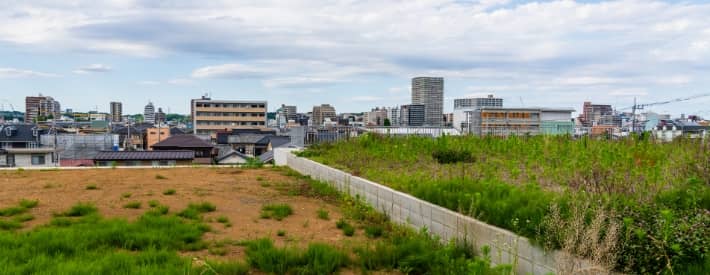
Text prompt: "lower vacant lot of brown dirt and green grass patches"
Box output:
[[0, 168, 504, 274]]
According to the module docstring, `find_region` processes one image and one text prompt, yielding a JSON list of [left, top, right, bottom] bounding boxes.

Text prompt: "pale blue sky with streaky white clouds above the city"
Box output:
[[0, 0, 710, 117]]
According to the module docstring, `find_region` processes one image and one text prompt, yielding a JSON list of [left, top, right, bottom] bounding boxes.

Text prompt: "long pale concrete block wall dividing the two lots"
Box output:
[[286, 152, 591, 275]]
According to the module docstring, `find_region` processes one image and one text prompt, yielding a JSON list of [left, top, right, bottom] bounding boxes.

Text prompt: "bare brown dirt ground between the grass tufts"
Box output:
[[0, 168, 367, 264]]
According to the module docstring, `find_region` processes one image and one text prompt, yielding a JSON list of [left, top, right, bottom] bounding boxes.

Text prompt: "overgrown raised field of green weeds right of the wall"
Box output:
[[301, 135, 710, 273]]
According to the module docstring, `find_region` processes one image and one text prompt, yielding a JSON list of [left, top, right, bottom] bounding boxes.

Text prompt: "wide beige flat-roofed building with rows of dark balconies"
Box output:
[[190, 96, 267, 137]]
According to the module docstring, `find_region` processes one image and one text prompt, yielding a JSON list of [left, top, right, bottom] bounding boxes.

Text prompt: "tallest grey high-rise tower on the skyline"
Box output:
[[412, 77, 444, 127]]
